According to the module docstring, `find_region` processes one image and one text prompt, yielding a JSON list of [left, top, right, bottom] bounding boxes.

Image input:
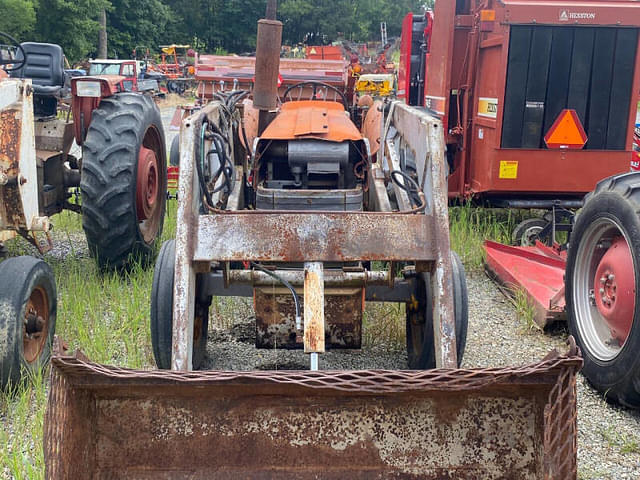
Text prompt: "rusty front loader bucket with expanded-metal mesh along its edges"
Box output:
[[44, 350, 582, 480]]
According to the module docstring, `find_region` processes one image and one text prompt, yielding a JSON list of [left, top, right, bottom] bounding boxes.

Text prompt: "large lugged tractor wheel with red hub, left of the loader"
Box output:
[[80, 93, 167, 268]]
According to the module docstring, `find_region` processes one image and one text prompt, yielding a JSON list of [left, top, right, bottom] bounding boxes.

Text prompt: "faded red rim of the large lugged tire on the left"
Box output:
[[136, 126, 166, 244]]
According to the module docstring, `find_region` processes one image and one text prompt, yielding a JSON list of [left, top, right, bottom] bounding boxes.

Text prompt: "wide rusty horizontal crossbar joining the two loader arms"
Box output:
[[194, 212, 435, 262]]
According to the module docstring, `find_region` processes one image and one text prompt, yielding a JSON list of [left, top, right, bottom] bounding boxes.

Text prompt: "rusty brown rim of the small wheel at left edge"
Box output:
[[22, 287, 49, 363]]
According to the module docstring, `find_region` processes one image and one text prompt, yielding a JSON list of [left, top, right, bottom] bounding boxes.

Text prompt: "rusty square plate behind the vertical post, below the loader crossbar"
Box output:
[[254, 284, 364, 349]]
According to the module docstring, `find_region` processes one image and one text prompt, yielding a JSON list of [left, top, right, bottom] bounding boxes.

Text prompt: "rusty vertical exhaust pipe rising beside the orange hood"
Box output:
[[253, 0, 282, 135]]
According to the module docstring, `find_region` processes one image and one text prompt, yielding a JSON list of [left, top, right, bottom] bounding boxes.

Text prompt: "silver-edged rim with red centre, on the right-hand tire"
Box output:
[[572, 217, 636, 362]]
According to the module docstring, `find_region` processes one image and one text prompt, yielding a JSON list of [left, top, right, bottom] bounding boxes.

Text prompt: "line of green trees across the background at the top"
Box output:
[[0, 0, 426, 62]]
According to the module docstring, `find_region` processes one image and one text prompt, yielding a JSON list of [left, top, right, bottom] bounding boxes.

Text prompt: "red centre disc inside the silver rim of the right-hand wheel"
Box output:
[[593, 236, 636, 345]]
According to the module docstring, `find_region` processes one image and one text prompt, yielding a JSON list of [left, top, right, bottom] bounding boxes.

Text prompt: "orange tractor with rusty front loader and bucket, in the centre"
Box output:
[[44, 1, 581, 479]]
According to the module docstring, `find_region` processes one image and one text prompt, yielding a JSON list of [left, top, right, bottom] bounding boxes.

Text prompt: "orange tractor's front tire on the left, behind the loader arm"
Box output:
[[151, 240, 211, 370]]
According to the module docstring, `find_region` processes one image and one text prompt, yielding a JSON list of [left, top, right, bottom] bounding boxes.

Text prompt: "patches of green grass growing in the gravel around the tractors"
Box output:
[[0, 201, 518, 479]]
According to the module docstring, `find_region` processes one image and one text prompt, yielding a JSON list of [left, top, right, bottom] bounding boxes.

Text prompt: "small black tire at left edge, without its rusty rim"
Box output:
[[0, 256, 57, 391]]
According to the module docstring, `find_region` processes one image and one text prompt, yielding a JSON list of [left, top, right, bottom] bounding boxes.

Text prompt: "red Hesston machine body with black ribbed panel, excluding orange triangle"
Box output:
[[398, 0, 640, 208]]
